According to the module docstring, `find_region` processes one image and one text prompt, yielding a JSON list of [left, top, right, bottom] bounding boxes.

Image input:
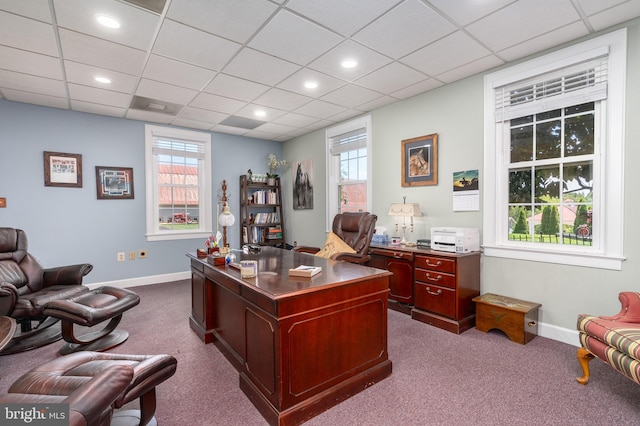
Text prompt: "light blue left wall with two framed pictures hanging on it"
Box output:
[[0, 100, 282, 283]]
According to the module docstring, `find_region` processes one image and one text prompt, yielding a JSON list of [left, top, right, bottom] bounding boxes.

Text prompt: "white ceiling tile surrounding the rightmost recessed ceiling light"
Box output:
[[309, 40, 392, 81]]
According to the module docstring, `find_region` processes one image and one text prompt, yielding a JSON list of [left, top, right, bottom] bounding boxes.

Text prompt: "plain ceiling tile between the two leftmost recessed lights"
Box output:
[[59, 28, 146, 76]]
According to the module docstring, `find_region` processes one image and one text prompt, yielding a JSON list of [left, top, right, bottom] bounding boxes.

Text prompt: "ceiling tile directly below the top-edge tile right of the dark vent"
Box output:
[[153, 20, 240, 71]]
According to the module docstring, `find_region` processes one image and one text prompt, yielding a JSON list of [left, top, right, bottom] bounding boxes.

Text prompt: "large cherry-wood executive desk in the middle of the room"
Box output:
[[187, 247, 392, 425]]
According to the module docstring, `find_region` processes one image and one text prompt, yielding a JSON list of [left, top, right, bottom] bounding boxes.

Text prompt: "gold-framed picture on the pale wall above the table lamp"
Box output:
[[402, 133, 438, 186]]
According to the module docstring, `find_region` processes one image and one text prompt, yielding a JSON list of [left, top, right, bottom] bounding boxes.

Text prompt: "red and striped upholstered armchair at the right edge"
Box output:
[[577, 292, 640, 385]]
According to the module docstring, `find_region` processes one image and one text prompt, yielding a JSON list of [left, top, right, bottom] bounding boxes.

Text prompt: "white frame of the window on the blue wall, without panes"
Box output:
[[145, 124, 213, 241]]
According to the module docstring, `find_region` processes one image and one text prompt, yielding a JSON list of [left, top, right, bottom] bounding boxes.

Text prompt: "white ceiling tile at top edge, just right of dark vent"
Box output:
[[167, 0, 278, 44]]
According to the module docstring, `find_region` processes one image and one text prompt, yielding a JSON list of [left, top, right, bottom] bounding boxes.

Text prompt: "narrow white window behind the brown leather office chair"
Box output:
[[327, 116, 372, 229]]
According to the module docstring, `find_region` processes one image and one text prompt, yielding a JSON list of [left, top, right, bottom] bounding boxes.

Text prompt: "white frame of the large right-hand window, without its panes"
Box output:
[[483, 29, 627, 270]]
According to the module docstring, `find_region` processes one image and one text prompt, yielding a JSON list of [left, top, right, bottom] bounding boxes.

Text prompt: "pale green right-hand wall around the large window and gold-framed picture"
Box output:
[[284, 20, 640, 343]]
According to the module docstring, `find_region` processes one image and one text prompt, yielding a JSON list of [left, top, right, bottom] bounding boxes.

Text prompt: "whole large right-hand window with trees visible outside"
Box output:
[[483, 30, 626, 269]]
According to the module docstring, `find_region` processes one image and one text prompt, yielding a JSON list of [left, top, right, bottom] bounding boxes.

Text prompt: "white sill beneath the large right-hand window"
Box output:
[[483, 246, 625, 271]]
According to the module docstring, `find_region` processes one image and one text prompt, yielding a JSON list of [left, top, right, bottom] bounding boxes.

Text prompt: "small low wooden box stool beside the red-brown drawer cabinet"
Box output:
[[472, 293, 542, 345]]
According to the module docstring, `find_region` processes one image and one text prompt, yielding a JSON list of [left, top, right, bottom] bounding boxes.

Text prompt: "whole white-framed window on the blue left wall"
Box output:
[[145, 125, 212, 241]]
